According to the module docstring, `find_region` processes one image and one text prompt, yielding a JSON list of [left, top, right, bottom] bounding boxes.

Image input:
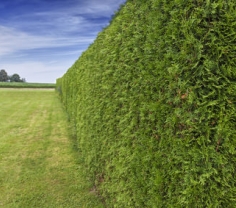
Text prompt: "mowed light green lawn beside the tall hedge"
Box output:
[[0, 89, 103, 208]]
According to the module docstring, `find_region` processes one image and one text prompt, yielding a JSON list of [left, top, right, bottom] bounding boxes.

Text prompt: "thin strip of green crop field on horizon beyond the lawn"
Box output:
[[0, 82, 56, 88]]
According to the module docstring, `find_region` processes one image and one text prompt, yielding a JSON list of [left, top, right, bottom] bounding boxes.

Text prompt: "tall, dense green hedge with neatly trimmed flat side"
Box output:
[[57, 0, 236, 208]]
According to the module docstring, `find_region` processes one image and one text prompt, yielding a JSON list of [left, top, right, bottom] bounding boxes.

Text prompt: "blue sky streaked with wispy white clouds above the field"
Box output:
[[0, 0, 125, 83]]
